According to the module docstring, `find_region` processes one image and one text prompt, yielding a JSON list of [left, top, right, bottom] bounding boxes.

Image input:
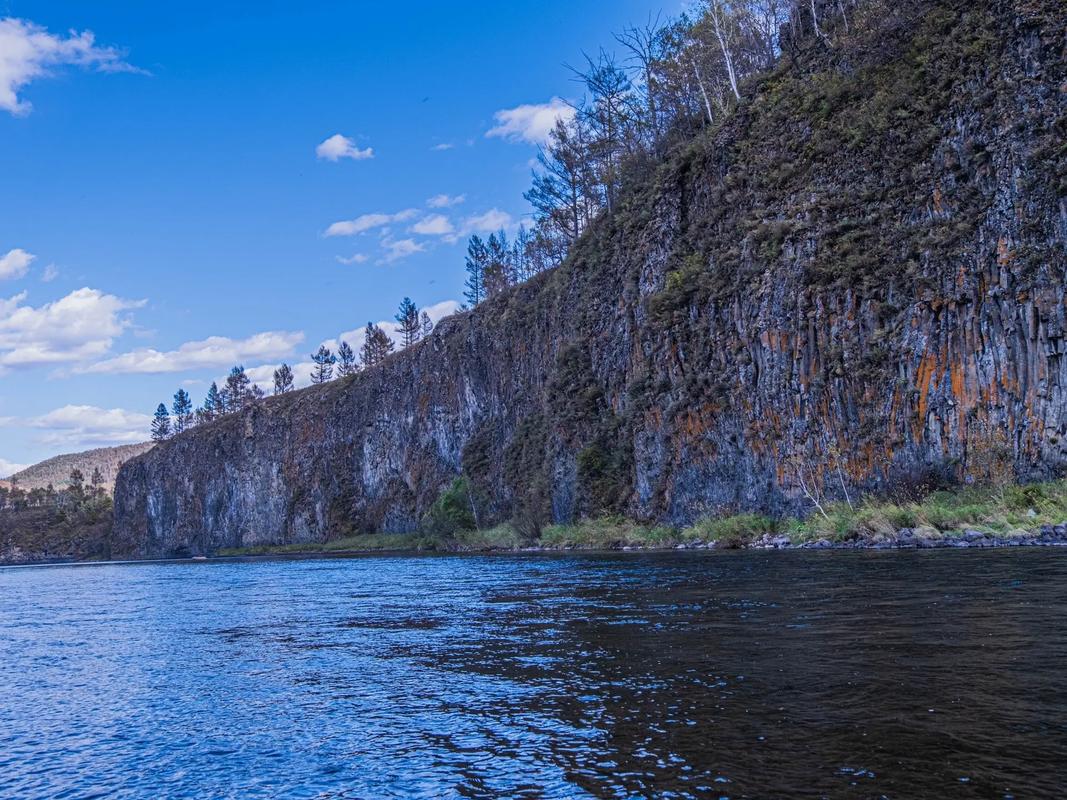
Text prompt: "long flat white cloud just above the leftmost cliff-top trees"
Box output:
[[78, 331, 304, 374]]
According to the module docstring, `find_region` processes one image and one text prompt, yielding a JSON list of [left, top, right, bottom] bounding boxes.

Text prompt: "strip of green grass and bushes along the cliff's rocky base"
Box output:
[[218, 480, 1067, 556]]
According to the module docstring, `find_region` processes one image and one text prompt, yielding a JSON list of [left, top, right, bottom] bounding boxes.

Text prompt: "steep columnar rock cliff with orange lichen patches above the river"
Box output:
[[112, 0, 1067, 556]]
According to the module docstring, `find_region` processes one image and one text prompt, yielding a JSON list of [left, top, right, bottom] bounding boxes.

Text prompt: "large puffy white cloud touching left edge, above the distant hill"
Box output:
[[0, 287, 144, 372]]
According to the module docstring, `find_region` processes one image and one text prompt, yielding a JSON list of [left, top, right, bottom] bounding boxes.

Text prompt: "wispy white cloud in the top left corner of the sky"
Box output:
[[0, 17, 143, 115]]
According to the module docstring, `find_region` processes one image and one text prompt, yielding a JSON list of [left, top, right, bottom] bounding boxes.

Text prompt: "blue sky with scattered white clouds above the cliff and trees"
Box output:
[[0, 0, 681, 475]]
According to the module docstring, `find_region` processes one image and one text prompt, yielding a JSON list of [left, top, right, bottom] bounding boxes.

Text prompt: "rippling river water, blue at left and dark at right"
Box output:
[[0, 549, 1067, 798]]
